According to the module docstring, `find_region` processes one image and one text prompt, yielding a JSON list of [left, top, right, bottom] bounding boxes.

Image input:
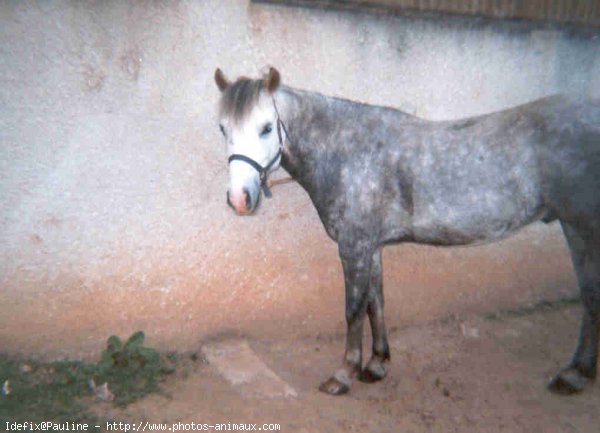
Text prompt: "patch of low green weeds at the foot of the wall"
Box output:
[[0, 332, 173, 423]]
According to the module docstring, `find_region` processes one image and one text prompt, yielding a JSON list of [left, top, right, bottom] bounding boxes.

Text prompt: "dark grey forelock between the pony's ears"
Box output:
[[219, 77, 265, 123]]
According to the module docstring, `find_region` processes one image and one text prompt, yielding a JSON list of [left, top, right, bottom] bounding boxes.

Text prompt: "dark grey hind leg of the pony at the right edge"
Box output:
[[548, 221, 600, 394]]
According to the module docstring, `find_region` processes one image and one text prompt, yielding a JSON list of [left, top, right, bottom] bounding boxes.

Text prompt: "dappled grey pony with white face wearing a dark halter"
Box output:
[[215, 68, 600, 394]]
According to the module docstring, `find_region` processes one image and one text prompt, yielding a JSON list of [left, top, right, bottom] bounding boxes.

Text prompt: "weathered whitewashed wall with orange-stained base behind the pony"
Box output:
[[0, 0, 600, 356]]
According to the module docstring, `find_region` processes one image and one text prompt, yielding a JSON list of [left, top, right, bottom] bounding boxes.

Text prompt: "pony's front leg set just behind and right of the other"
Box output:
[[360, 249, 390, 383]]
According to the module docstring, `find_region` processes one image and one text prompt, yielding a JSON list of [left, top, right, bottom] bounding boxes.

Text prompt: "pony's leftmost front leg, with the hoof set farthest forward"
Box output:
[[319, 245, 373, 395]]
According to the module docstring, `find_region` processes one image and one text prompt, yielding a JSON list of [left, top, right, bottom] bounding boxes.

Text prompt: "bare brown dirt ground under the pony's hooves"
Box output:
[[88, 304, 600, 433]]
